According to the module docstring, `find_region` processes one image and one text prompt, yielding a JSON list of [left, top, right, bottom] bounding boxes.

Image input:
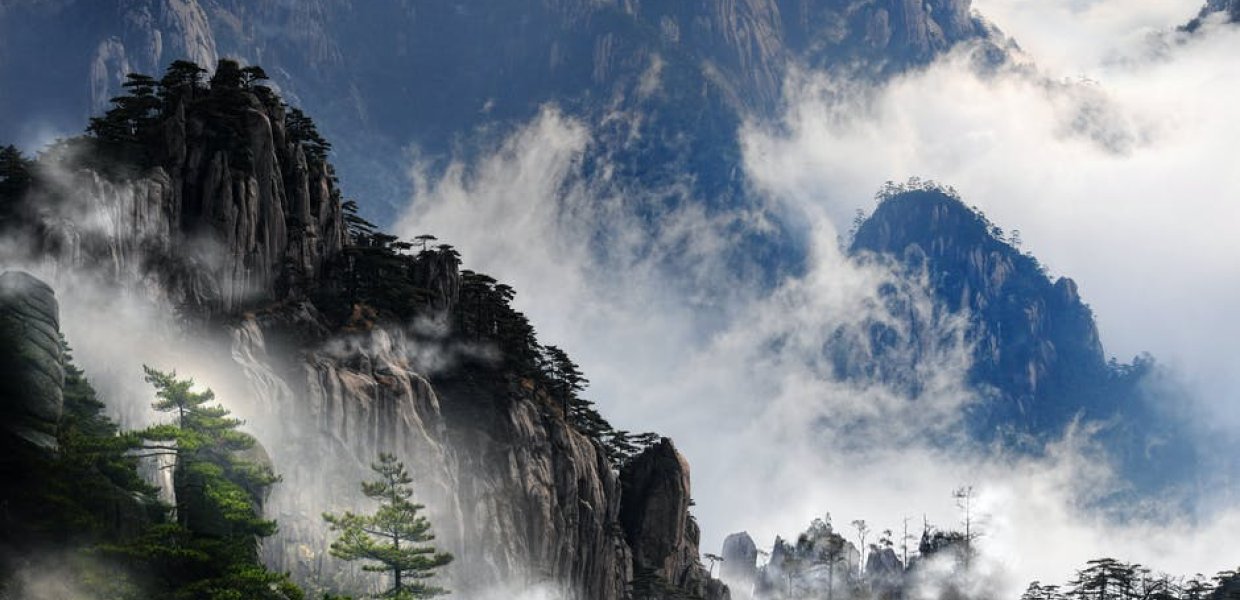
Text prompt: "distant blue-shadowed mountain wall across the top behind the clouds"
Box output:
[[0, 0, 1006, 255]]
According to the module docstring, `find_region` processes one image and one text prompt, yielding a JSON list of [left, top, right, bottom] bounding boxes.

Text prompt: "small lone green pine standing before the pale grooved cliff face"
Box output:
[[322, 454, 453, 599]]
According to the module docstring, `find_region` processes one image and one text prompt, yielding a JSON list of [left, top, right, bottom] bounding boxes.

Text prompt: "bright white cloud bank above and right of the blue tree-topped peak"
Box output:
[[743, 19, 1240, 426]]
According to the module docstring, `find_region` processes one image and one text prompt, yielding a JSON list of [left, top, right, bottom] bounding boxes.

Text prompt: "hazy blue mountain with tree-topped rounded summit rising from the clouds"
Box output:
[[849, 185, 1209, 492]]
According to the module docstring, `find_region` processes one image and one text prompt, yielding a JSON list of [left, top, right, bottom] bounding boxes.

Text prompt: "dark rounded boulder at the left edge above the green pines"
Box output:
[[0, 271, 64, 451]]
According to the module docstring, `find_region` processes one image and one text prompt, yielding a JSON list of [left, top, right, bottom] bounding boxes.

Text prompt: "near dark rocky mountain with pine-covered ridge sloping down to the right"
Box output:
[[0, 61, 728, 599]]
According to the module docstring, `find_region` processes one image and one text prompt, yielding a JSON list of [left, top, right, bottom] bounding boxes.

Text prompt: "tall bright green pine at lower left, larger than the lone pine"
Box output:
[[123, 367, 303, 600]]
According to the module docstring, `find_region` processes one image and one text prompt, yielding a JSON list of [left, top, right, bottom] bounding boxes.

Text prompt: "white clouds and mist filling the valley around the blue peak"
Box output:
[[396, 0, 1240, 596]]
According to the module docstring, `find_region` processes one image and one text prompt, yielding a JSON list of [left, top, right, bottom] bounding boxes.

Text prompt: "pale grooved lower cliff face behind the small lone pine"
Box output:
[[232, 306, 728, 600]]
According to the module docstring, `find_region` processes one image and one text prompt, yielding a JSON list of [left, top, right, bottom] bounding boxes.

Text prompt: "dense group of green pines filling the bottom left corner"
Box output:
[[0, 346, 304, 600]]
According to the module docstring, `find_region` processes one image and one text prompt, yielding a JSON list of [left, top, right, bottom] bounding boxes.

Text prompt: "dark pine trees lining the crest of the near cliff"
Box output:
[[0, 60, 658, 466]]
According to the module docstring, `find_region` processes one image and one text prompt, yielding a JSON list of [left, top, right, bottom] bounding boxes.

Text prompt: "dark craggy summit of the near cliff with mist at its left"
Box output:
[[30, 69, 345, 317]]
